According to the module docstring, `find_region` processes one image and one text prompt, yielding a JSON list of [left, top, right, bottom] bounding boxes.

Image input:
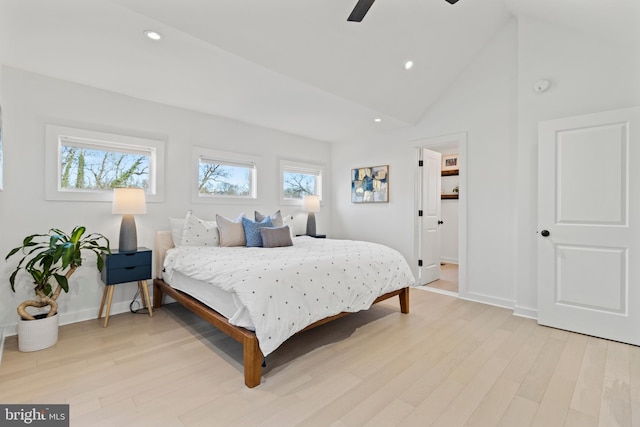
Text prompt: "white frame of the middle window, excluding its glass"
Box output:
[[191, 147, 260, 204]]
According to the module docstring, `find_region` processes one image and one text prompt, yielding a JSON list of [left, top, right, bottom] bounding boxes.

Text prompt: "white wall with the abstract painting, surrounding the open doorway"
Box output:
[[332, 21, 517, 306]]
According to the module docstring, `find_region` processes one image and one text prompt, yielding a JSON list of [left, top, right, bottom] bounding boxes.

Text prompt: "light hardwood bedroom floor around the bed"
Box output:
[[0, 289, 640, 427]]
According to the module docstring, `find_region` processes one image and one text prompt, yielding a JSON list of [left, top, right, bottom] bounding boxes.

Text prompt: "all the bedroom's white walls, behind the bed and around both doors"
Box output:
[[0, 13, 640, 332]]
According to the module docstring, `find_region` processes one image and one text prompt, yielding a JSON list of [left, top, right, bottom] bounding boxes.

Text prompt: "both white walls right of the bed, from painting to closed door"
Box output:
[[333, 18, 640, 317]]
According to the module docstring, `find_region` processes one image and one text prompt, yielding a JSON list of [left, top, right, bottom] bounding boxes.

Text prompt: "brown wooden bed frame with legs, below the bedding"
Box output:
[[153, 279, 409, 388]]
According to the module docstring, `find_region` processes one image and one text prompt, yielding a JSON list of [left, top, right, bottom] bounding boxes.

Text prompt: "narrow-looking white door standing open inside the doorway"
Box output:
[[419, 148, 442, 285]]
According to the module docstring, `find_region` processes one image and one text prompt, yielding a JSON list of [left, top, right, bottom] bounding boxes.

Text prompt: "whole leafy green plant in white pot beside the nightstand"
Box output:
[[5, 226, 111, 351]]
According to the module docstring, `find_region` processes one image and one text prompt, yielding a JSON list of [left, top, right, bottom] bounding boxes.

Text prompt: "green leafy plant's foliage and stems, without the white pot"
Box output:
[[5, 226, 111, 320]]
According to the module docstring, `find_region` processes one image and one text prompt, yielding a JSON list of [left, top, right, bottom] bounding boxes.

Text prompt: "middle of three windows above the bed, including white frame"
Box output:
[[193, 147, 258, 203]]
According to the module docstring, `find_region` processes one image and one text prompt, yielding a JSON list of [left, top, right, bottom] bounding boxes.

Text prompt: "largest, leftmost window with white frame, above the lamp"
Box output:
[[46, 125, 164, 201]]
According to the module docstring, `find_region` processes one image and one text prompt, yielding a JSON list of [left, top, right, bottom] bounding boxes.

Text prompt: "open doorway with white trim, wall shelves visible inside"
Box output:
[[414, 133, 467, 295]]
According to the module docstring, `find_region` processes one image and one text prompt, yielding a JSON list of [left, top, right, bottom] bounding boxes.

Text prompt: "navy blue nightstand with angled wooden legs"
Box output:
[[98, 247, 153, 328]]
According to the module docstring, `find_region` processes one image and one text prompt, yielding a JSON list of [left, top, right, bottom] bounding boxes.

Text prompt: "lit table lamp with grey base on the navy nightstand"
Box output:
[[112, 188, 147, 252]]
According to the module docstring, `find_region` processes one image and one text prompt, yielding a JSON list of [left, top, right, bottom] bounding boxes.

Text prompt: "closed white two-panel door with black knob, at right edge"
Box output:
[[538, 108, 640, 345]]
